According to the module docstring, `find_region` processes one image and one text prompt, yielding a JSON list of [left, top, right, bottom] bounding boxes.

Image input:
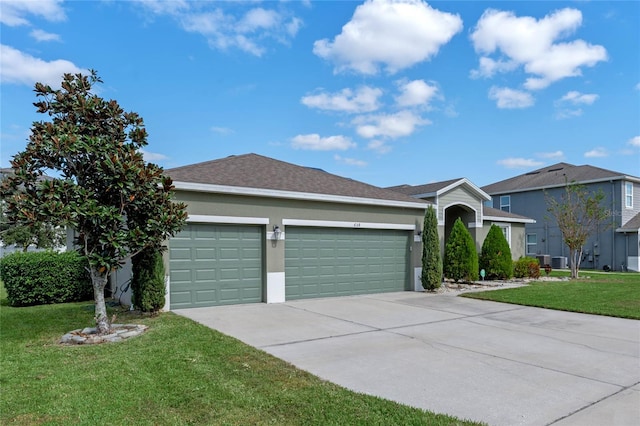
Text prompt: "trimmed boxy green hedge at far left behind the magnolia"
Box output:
[[0, 251, 93, 306]]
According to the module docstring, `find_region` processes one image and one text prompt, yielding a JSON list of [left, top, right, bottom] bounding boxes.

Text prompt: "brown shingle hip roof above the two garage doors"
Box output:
[[166, 154, 423, 206]]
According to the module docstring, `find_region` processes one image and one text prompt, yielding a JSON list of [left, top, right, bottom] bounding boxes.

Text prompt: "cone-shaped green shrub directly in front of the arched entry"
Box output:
[[443, 218, 478, 281]]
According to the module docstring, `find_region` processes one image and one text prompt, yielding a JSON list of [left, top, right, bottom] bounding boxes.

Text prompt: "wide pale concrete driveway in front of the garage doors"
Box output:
[[175, 292, 640, 426]]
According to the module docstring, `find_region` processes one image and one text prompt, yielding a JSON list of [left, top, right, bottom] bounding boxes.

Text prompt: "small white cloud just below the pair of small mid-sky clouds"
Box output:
[[352, 111, 431, 139]]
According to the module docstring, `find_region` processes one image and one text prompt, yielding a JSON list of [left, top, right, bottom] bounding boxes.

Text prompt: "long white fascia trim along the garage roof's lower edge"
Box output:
[[173, 182, 429, 210]]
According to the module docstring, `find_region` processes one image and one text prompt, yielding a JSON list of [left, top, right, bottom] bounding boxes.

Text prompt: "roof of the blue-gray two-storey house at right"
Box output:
[[482, 163, 640, 195]]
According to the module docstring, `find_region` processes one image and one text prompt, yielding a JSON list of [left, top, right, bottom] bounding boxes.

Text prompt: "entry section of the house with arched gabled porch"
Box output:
[[387, 178, 535, 260]]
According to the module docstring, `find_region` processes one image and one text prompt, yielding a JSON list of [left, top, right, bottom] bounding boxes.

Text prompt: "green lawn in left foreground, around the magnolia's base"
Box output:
[[0, 296, 478, 425]]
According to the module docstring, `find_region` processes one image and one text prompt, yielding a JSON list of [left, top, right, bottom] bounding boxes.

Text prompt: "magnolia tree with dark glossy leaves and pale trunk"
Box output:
[[1, 71, 187, 334]]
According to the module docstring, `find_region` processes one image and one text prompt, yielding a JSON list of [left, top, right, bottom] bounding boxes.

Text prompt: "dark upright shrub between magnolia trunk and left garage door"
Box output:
[[131, 248, 165, 312]]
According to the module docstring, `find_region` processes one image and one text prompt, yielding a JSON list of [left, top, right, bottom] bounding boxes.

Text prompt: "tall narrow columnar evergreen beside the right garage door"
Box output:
[[420, 206, 442, 290]]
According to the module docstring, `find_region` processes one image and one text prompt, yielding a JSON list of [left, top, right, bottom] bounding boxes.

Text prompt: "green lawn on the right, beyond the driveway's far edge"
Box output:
[[462, 271, 640, 319]]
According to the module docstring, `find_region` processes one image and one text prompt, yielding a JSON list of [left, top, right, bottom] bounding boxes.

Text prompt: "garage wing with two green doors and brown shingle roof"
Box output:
[[115, 154, 428, 309]]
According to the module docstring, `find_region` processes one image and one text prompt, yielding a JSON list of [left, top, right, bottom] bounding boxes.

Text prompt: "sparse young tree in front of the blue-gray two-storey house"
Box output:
[[545, 182, 612, 278]]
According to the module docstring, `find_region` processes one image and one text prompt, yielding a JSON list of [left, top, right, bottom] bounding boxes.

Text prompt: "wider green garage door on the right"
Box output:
[[285, 226, 410, 300]]
